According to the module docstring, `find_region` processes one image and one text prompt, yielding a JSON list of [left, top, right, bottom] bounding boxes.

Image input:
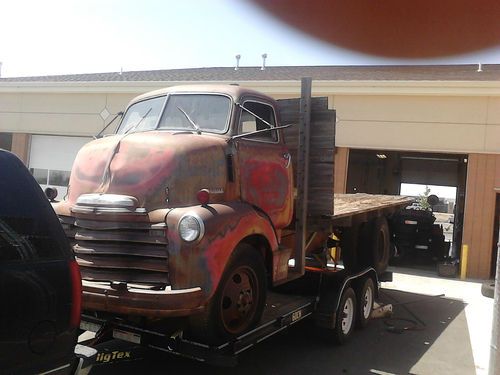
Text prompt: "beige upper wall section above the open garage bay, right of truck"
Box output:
[[335, 95, 500, 153]]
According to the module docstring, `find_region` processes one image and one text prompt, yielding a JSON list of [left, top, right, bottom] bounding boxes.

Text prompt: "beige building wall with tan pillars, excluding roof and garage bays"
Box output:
[[0, 81, 500, 278]]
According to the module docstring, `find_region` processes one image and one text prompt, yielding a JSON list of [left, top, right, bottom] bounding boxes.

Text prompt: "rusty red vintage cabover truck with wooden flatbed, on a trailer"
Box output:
[[54, 79, 409, 364]]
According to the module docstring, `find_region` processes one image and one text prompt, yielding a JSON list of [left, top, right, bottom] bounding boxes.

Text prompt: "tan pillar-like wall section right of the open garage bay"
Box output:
[[463, 154, 500, 279]]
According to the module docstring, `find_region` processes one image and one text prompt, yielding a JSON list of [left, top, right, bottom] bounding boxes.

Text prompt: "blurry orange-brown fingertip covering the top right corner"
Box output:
[[253, 0, 500, 58]]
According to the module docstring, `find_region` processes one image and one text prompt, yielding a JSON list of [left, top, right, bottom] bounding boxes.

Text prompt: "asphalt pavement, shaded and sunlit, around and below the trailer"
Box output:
[[85, 270, 493, 375]]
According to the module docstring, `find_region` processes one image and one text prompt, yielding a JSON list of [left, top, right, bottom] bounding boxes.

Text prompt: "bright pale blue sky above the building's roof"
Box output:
[[0, 0, 500, 77]]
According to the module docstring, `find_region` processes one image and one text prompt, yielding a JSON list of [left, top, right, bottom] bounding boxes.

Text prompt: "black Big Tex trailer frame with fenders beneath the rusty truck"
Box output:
[[80, 267, 380, 366]]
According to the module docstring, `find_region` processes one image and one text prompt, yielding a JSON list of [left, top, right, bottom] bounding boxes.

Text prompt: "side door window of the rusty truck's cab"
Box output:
[[240, 101, 278, 142]]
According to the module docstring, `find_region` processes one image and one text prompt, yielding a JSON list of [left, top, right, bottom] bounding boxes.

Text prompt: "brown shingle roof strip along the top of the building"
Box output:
[[0, 64, 500, 83]]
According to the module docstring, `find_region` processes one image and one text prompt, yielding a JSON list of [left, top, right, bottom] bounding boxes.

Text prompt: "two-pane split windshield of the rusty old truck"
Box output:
[[117, 94, 231, 134]]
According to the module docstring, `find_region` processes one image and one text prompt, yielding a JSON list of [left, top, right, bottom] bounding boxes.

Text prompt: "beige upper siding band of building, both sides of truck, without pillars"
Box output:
[[0, 89, 500, 153]]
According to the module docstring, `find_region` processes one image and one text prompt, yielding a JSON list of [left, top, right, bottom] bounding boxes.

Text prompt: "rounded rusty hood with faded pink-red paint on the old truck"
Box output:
[[68, 131, 227, 212]]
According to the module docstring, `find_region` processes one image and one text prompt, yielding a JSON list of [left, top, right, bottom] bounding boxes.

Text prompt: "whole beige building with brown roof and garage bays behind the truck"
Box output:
[[0, 65, 500, 278]]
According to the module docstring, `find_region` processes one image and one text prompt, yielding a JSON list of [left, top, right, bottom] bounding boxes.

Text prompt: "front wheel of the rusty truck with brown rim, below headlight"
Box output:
[[190, 243, 266, 343]]
